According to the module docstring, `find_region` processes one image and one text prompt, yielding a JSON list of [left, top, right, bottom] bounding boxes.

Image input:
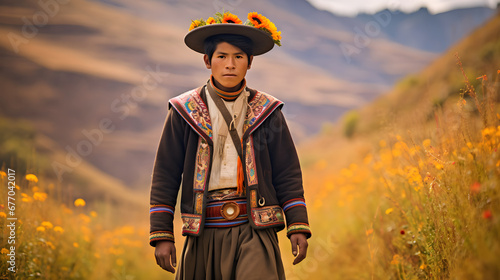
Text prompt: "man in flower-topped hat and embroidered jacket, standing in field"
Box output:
[[150, 13, 311, 279]]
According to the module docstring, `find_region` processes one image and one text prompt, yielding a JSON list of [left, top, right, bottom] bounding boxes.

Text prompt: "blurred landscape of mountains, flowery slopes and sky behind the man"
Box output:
[[0, 0, 500, 279]]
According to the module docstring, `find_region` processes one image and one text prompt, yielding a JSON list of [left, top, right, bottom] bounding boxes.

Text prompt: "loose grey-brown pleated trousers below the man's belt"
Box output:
[[175, 223, 285, 280]]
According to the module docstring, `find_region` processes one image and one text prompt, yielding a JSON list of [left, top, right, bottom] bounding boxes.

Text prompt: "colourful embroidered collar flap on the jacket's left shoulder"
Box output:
[[171, 90, 212, 138]]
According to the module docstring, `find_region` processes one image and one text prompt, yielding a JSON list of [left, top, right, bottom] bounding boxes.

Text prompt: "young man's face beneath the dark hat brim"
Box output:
[[204, 42, 253, 92]]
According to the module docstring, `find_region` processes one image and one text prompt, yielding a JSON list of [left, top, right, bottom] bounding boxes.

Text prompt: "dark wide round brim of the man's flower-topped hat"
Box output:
[[184, 23, 274, 55]]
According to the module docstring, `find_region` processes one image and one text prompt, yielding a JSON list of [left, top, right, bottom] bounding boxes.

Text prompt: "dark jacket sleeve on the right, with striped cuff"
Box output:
[[268, 109, 311, 238]]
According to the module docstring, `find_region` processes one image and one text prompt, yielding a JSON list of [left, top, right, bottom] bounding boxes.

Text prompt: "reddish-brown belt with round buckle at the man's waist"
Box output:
[[205, 199, 248, 227]]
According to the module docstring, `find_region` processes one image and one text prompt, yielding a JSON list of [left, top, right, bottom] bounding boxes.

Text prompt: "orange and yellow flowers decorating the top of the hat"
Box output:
[[189, 12, 281, 47]]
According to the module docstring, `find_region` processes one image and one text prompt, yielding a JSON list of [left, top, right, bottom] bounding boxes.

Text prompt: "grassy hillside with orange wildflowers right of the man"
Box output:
[[291, 12, 500, 279]]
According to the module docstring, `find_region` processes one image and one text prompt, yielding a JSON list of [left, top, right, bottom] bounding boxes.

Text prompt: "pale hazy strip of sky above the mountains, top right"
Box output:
[[307, 0, 500, 16]]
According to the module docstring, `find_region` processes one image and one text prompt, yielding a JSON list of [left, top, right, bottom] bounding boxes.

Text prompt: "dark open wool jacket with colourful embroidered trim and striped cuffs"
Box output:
[[150, 87, 311, 246]]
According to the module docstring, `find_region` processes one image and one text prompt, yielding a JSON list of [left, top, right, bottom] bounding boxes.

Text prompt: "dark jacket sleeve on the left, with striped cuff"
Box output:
[[149, 108, 186, 247]]
